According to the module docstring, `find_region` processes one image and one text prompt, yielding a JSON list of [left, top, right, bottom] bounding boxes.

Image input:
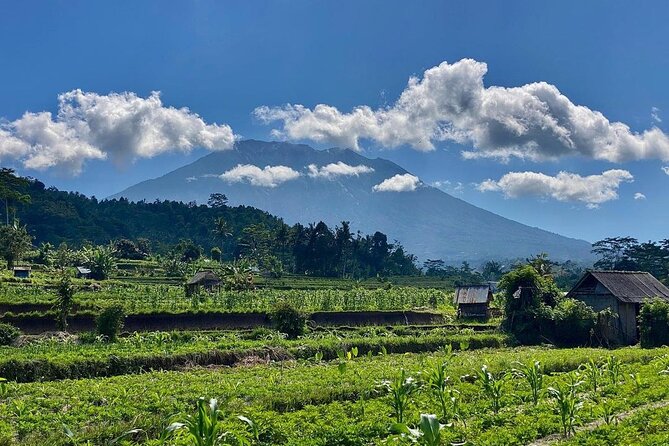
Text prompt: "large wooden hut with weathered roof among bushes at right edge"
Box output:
[[566, 271, 669, 344]]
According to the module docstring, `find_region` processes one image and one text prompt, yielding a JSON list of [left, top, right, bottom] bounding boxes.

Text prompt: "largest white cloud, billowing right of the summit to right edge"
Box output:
[[254, 59, 669, 162]]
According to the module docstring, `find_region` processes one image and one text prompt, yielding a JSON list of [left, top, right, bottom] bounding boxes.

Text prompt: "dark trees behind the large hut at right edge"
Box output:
[[592, 237, 669, 283]]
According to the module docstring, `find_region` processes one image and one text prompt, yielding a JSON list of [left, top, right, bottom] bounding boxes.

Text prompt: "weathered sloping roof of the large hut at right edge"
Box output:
[[567, 271, 669, 303]]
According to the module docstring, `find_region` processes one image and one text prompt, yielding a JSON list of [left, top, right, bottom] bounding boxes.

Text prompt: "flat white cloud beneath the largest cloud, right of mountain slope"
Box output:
[[478, 169, 634, 208]]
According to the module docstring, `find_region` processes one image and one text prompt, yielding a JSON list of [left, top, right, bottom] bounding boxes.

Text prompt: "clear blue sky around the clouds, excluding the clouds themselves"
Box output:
[[0, 0, 669, 241]]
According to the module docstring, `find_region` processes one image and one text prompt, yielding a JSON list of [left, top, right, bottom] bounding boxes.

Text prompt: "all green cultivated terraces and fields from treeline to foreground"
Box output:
[[0, 270, 669, 445]]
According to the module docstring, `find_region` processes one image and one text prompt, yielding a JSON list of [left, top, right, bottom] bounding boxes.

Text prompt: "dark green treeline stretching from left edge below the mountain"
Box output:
[[0, 169, 420, 278]]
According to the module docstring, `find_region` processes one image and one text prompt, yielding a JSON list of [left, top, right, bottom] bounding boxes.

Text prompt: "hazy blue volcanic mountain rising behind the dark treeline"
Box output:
[[114, 140, 591, 261]]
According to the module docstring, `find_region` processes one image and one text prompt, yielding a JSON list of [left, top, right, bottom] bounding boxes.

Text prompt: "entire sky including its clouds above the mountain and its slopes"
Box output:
[[0, 0, 669, 241]]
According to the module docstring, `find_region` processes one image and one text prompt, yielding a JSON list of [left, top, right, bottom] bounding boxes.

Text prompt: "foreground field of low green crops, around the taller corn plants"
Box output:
[[0, 348, 669, 445]]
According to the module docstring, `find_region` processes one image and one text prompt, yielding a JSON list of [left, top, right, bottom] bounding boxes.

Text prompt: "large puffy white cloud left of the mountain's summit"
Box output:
[[0, 90, 235, 174]]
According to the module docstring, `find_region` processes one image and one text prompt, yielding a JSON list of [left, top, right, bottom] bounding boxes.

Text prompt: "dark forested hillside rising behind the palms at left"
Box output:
[[18, 180, 284, 250]]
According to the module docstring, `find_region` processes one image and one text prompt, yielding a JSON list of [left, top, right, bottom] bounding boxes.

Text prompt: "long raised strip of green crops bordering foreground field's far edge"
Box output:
[[0, 329, 508, 382]]
